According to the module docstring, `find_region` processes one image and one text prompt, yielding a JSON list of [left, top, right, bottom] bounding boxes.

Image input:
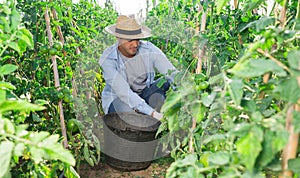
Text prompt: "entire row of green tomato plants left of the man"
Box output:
[[0, 0, 117, 177]]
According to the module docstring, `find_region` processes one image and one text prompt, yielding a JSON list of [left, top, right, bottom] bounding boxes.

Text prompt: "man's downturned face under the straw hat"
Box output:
[[118, 38, 140, 58]]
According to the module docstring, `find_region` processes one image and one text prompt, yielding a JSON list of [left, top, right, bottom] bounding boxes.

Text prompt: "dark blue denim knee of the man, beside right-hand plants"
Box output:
[[140, 80, 170, 112]]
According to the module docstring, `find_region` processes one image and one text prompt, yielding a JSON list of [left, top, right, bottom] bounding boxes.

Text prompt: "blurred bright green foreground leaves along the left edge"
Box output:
[[0, 1, 75, 177]]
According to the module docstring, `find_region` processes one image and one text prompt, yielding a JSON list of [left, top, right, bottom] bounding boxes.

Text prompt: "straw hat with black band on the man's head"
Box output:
[[105, 15, 151, 39]]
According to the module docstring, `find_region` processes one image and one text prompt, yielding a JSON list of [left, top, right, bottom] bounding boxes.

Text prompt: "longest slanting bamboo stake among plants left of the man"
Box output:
[[45, 7, 68, 148]]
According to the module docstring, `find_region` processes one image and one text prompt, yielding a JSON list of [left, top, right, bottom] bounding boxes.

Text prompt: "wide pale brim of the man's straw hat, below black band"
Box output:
[[105, 24, 151, 39]]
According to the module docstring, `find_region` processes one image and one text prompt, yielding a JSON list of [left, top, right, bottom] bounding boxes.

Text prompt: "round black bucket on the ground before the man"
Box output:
[[103, 112, 160, 171]]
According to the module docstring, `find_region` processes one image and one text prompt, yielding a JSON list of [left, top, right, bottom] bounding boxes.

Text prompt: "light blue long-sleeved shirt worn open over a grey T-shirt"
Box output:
[[99, 41, 176, 115]]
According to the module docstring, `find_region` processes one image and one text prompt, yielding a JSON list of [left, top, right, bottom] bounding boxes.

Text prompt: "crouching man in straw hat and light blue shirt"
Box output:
[[99, 15, 176, 120]]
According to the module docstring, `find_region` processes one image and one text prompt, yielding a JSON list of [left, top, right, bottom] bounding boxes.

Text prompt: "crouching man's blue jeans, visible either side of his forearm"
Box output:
[[108, 80, 170, 113]]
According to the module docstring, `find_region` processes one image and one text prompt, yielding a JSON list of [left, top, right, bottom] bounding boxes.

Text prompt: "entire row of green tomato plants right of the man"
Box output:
[[149, 0, 300, 177]]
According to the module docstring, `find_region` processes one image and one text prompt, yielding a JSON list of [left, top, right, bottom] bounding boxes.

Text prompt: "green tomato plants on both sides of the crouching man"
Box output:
[[0, 0, 300, 177]]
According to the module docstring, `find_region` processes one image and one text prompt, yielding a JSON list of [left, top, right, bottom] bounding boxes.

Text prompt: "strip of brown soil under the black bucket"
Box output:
[[79, 158, 173, 178]]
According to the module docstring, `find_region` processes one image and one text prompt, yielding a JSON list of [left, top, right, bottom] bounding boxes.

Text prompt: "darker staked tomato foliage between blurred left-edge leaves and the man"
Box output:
[[9, 0, 116, 172]]
